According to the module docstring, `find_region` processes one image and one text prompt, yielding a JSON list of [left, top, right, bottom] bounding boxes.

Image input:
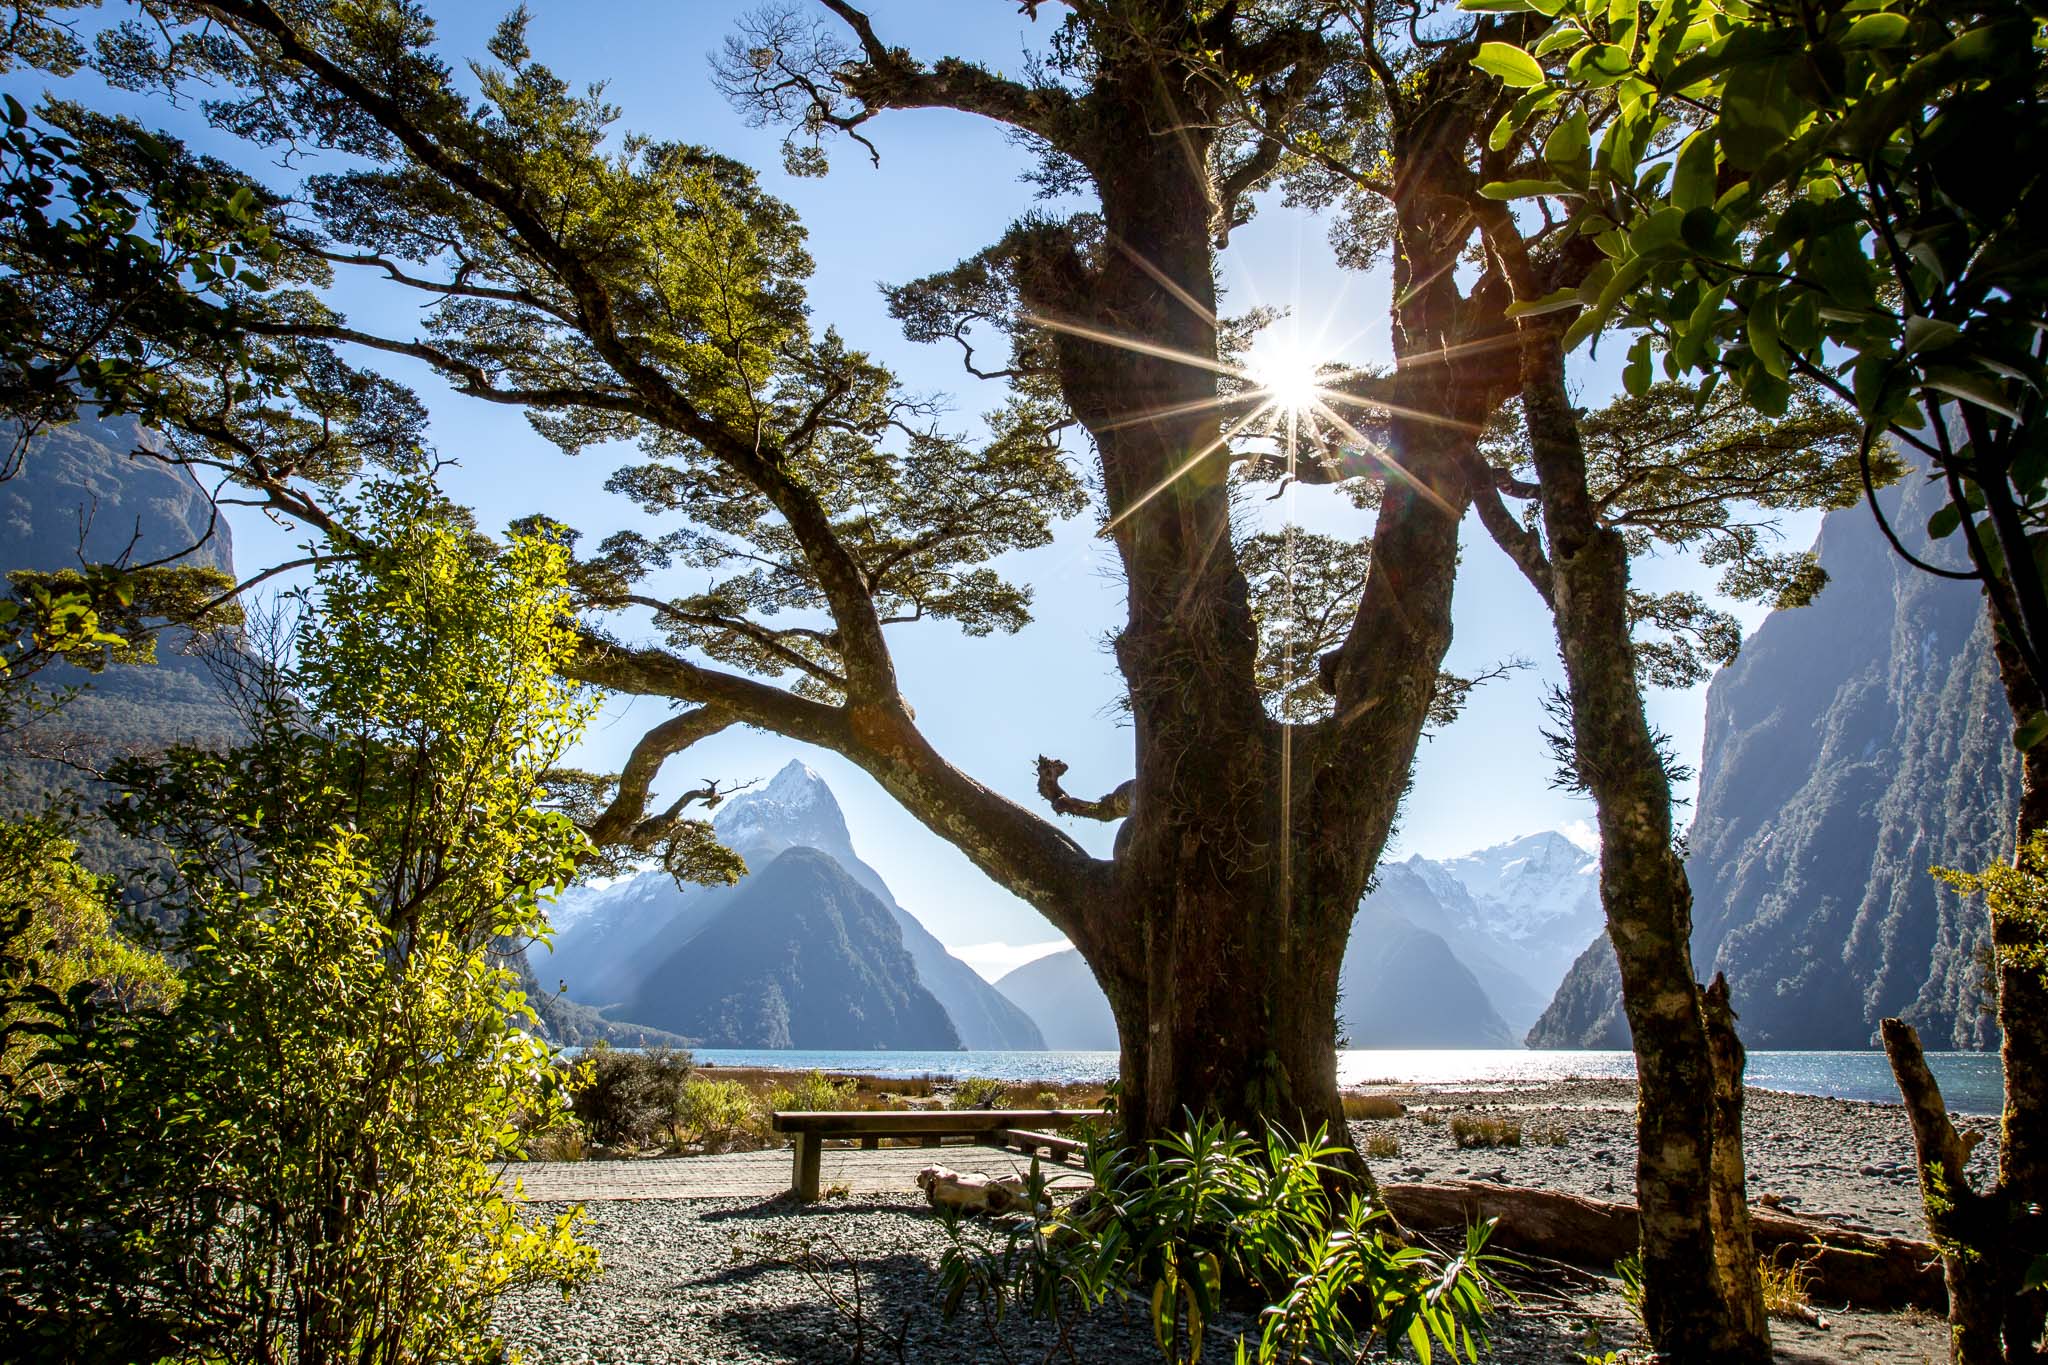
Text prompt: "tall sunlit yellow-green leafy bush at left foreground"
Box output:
[[0, 483, 596, 1365]]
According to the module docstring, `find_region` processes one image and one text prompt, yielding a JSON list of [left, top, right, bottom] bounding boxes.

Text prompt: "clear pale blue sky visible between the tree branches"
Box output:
[[4, 0, 1817, 966]]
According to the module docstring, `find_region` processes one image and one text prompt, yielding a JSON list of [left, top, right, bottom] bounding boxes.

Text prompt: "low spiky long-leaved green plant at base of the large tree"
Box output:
[[938, 1121, 1505, 1365]]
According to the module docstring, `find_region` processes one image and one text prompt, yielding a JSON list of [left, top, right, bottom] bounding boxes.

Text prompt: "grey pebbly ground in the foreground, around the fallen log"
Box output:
[[487, 1083, 1987, 1365]]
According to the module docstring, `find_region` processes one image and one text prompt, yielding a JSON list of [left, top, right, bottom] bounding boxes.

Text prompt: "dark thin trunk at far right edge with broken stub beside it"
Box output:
[[1882, 626, 2048, 1365]]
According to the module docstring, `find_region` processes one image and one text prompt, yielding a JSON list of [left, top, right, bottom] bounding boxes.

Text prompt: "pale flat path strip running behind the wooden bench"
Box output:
[[504, 1146, 1087, 1203]]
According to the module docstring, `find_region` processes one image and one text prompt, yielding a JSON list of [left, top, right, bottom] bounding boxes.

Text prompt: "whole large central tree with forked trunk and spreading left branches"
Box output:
[[8, 0, 1507, 1162]]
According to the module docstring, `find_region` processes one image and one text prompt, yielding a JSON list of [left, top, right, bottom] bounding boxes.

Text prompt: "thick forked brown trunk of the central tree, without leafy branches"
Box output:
[[1040, 98, 1473, 1173]]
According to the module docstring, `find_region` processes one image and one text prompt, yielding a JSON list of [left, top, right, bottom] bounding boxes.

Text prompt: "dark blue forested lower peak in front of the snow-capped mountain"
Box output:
[[623, 847, 961, 1050]]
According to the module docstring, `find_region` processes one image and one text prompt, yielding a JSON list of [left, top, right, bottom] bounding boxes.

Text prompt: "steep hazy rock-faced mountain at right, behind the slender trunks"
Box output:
[[1530, 458, 2017, 1048]]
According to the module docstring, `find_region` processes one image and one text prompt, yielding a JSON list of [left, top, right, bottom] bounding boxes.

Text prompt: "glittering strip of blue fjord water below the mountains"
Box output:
[[696, 1048, 2003, 1113]]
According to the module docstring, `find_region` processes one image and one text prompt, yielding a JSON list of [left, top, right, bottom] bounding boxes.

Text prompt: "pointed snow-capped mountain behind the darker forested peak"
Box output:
[[541, 761, 1044, 1052]]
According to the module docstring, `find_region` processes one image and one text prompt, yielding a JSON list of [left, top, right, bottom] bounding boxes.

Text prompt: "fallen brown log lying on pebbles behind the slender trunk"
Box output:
[[1380, 1181, 1948, 1312]]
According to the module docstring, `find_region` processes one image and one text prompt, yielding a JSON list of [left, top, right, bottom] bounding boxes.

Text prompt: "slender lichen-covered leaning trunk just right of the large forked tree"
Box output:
[[1522, 323, 1769, 1365]]
